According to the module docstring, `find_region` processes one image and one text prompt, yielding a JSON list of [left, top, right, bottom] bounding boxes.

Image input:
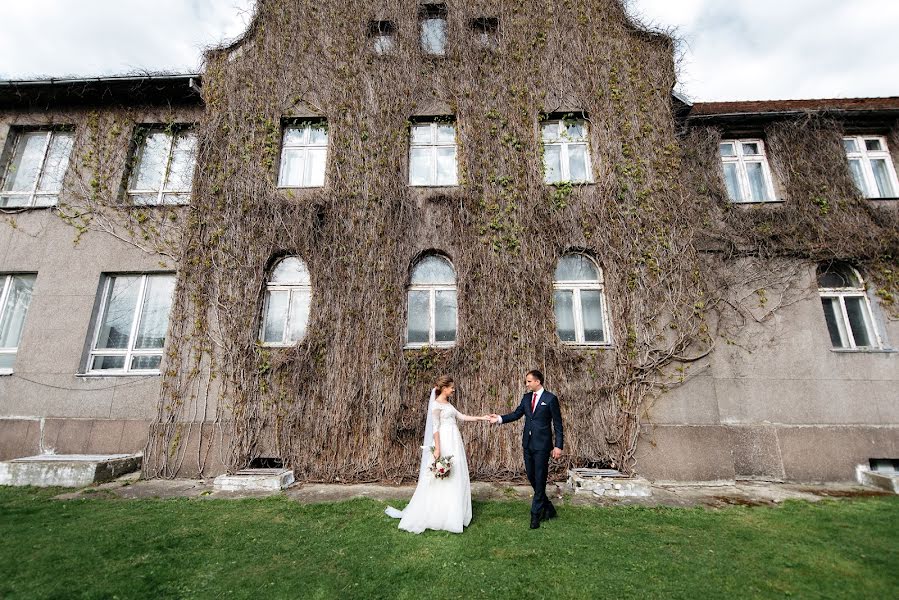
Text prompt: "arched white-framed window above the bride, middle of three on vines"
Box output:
[[406, 255, 458, 347]]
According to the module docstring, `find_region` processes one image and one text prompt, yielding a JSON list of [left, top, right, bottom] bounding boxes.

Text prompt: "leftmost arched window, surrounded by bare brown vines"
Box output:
[[261, 256, 312, 346]]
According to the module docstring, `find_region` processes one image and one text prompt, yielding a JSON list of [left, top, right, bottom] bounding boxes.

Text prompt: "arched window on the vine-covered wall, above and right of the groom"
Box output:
[[553, 254, 609, 345]]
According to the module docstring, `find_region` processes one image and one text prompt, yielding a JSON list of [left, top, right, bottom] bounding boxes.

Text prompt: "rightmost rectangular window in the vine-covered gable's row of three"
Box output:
[[540, 119, 593, 184]]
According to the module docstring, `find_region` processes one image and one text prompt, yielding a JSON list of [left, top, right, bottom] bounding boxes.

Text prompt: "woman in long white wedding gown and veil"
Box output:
[[385, 375, 488, 533]]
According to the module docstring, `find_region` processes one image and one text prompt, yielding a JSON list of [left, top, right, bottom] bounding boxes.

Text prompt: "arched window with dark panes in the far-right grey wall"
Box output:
[[818, 263, 878, 349]]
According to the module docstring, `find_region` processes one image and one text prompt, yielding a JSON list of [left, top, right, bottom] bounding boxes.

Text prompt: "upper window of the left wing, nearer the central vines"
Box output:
[[128, 127, 197, 206]]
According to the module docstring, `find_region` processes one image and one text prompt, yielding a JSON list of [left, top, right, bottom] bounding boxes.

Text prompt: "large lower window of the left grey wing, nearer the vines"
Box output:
[[87, 273, 175, 374]]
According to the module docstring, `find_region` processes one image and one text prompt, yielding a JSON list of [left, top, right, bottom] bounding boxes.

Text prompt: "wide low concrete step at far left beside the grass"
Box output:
[[0, 454, 143, 487]]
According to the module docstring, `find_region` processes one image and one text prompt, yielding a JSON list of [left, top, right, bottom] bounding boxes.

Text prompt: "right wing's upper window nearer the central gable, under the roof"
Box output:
[[718, 140, 776, 202]]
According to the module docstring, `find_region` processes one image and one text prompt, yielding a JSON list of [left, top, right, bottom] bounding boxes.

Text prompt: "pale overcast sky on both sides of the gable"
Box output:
[[0, 0, 899, 101]]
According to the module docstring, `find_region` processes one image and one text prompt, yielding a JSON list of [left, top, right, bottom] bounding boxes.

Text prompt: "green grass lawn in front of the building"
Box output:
[[0, 488, 899, 600]]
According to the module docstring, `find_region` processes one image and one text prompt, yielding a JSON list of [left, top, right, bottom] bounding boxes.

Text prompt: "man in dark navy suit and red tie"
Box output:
[[490, 369, 563, 529]]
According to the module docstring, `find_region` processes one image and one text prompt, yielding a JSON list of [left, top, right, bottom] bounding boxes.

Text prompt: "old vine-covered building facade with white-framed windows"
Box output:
[[0, 0, 899, 481]]
